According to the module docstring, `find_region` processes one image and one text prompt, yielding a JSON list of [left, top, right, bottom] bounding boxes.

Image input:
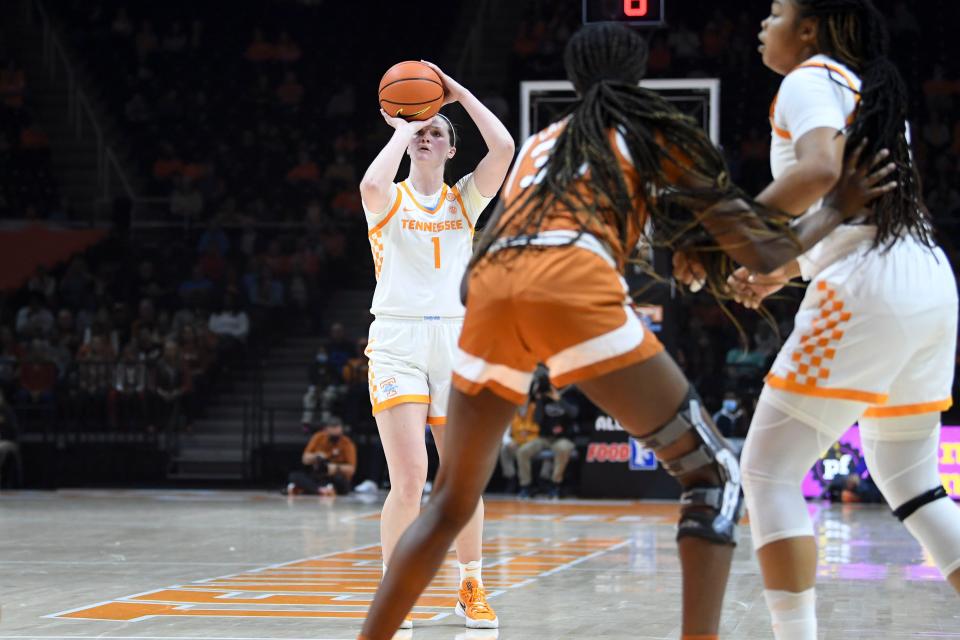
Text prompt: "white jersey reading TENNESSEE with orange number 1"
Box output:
[[363, 173, 491, 318]]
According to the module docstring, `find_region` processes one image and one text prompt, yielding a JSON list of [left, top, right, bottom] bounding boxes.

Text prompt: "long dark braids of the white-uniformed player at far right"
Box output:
[[793, 0, 934, 247]]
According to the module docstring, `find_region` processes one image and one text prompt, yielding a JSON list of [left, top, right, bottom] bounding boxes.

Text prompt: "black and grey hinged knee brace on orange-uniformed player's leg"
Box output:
[[639, 386, 743, 545]]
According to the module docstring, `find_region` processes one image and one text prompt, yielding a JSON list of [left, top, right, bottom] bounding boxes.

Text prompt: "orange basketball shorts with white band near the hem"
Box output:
[[453, 238, 663, 404]]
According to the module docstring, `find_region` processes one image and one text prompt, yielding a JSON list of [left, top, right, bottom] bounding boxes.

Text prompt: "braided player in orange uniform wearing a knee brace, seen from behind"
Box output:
[[361, 24, 893, 640]]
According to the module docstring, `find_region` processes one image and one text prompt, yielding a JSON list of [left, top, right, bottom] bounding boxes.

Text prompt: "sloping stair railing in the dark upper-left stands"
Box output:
[[25, 0, 137, 216]]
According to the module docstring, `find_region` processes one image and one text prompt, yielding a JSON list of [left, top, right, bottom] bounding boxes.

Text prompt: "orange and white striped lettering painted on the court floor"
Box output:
[[47, 536, 627, 622]]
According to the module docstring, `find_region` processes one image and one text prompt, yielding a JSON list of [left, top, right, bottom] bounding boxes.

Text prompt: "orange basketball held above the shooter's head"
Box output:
[[379, 60, 443, 120]]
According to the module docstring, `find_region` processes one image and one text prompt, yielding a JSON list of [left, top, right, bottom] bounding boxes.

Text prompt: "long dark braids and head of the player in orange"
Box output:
[[473, 23, 792, 296]]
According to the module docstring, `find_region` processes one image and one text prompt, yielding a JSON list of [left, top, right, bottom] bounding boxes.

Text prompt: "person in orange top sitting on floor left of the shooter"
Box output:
[[286, 417, 357, 496]]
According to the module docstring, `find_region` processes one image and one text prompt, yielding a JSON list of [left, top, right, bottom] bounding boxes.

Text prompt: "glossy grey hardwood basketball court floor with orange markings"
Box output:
[[0, 491, 960, 640]]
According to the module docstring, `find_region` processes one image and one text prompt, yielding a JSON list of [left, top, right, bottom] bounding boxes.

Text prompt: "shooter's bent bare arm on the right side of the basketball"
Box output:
[[421, 60, 516, 198]]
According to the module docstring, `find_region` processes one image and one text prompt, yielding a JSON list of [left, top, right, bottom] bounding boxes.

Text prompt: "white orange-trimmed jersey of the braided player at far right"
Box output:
[[770, 55, 876, 280]]
